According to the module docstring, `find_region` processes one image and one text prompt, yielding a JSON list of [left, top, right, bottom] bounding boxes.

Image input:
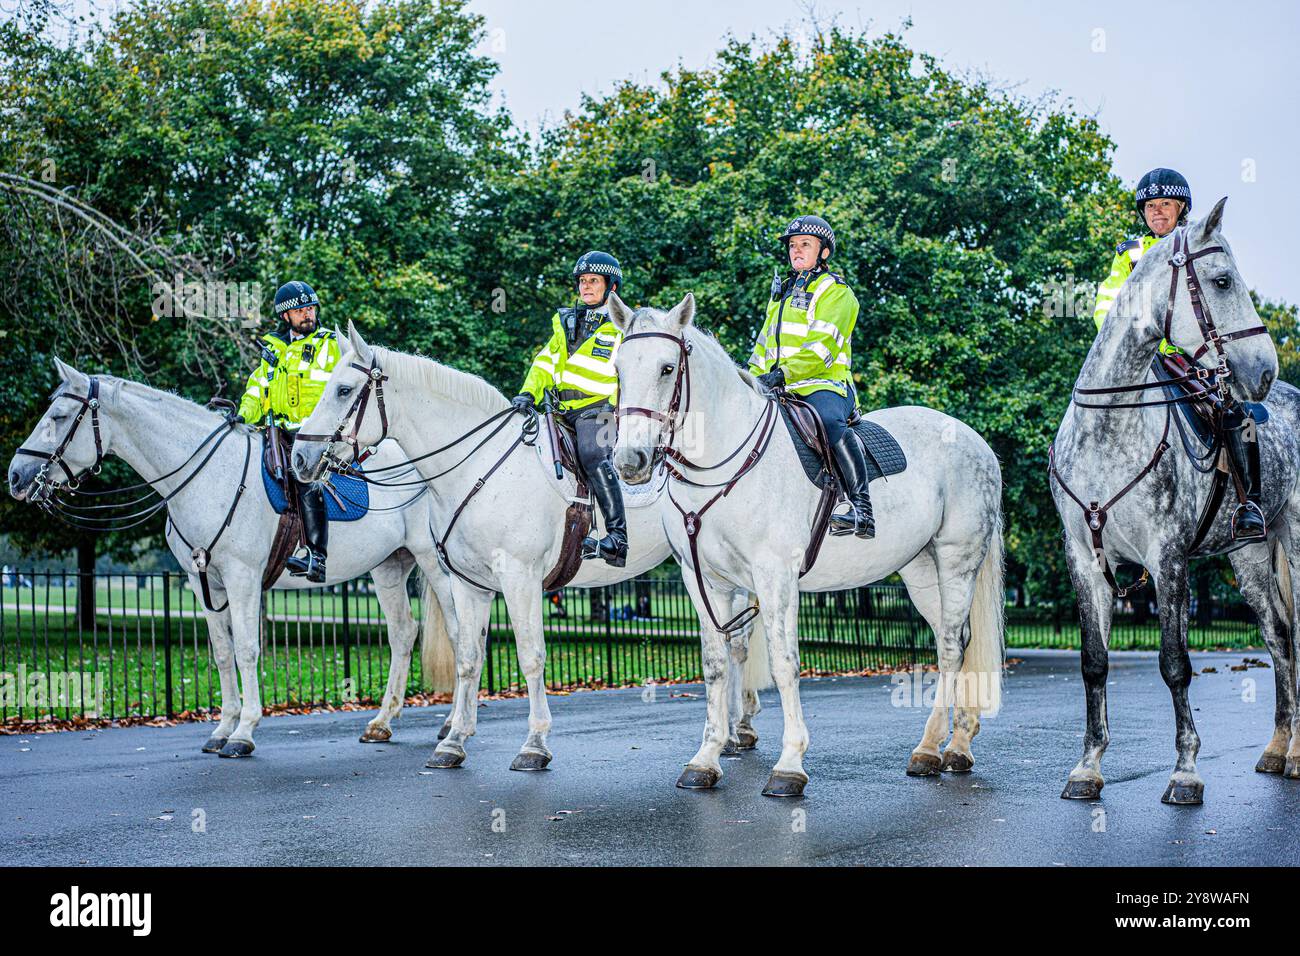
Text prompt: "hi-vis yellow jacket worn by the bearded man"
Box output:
[[239, 329, 339, 429]]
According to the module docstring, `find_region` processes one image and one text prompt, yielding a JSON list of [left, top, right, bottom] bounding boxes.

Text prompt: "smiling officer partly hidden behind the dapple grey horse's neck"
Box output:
[[1093, 168, 1265, 541]]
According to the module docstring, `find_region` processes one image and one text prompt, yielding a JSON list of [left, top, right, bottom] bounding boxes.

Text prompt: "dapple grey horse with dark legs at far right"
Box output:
[[1049, 199, 1300, 804]]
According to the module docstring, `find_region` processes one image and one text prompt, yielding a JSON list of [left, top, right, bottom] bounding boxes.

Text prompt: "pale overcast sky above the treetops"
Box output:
[[471, 0, 1300, 303]]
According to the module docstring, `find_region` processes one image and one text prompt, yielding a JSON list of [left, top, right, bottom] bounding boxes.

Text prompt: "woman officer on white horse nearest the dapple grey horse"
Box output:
[[749, 216, 876, 537]]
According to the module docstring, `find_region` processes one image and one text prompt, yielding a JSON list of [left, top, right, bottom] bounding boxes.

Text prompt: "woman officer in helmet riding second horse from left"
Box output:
[[514, 251, 628, 567]]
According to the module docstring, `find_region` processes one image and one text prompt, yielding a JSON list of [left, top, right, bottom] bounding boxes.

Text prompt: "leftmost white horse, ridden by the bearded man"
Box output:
[[9, 359, 450, 757]]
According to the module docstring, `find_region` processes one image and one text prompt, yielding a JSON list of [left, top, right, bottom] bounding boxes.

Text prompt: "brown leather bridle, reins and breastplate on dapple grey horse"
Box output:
[[1048, 226, 1269, 598]]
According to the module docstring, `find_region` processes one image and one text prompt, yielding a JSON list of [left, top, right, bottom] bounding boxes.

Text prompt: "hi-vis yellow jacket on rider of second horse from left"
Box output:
[[520, 308, 623, 411]]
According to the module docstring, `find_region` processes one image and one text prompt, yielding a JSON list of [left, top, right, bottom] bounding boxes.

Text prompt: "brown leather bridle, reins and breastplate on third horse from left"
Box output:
[[616, 332, 777, 636]]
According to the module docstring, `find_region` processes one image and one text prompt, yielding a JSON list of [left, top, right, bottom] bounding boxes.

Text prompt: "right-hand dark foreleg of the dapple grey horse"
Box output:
[[1156, 555, 1205, 804]]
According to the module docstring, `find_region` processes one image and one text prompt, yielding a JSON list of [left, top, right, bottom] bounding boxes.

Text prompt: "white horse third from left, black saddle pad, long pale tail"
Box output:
[[610, 294, 1004, 796]]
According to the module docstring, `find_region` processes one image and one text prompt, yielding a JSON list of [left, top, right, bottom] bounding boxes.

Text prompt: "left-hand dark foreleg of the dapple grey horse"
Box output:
[[1061, 537, 1114, 800]]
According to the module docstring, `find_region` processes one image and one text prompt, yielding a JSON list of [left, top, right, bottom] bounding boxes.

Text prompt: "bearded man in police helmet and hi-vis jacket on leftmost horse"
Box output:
[[238, 281, 339, 584]]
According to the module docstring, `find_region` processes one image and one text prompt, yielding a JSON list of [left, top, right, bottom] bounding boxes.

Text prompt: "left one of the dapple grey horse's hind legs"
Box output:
[[1229, 542, 1295, 774]]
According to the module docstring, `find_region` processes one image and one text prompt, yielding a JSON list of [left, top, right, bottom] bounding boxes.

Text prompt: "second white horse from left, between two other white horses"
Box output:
[[293, 323, 766, 770]]
